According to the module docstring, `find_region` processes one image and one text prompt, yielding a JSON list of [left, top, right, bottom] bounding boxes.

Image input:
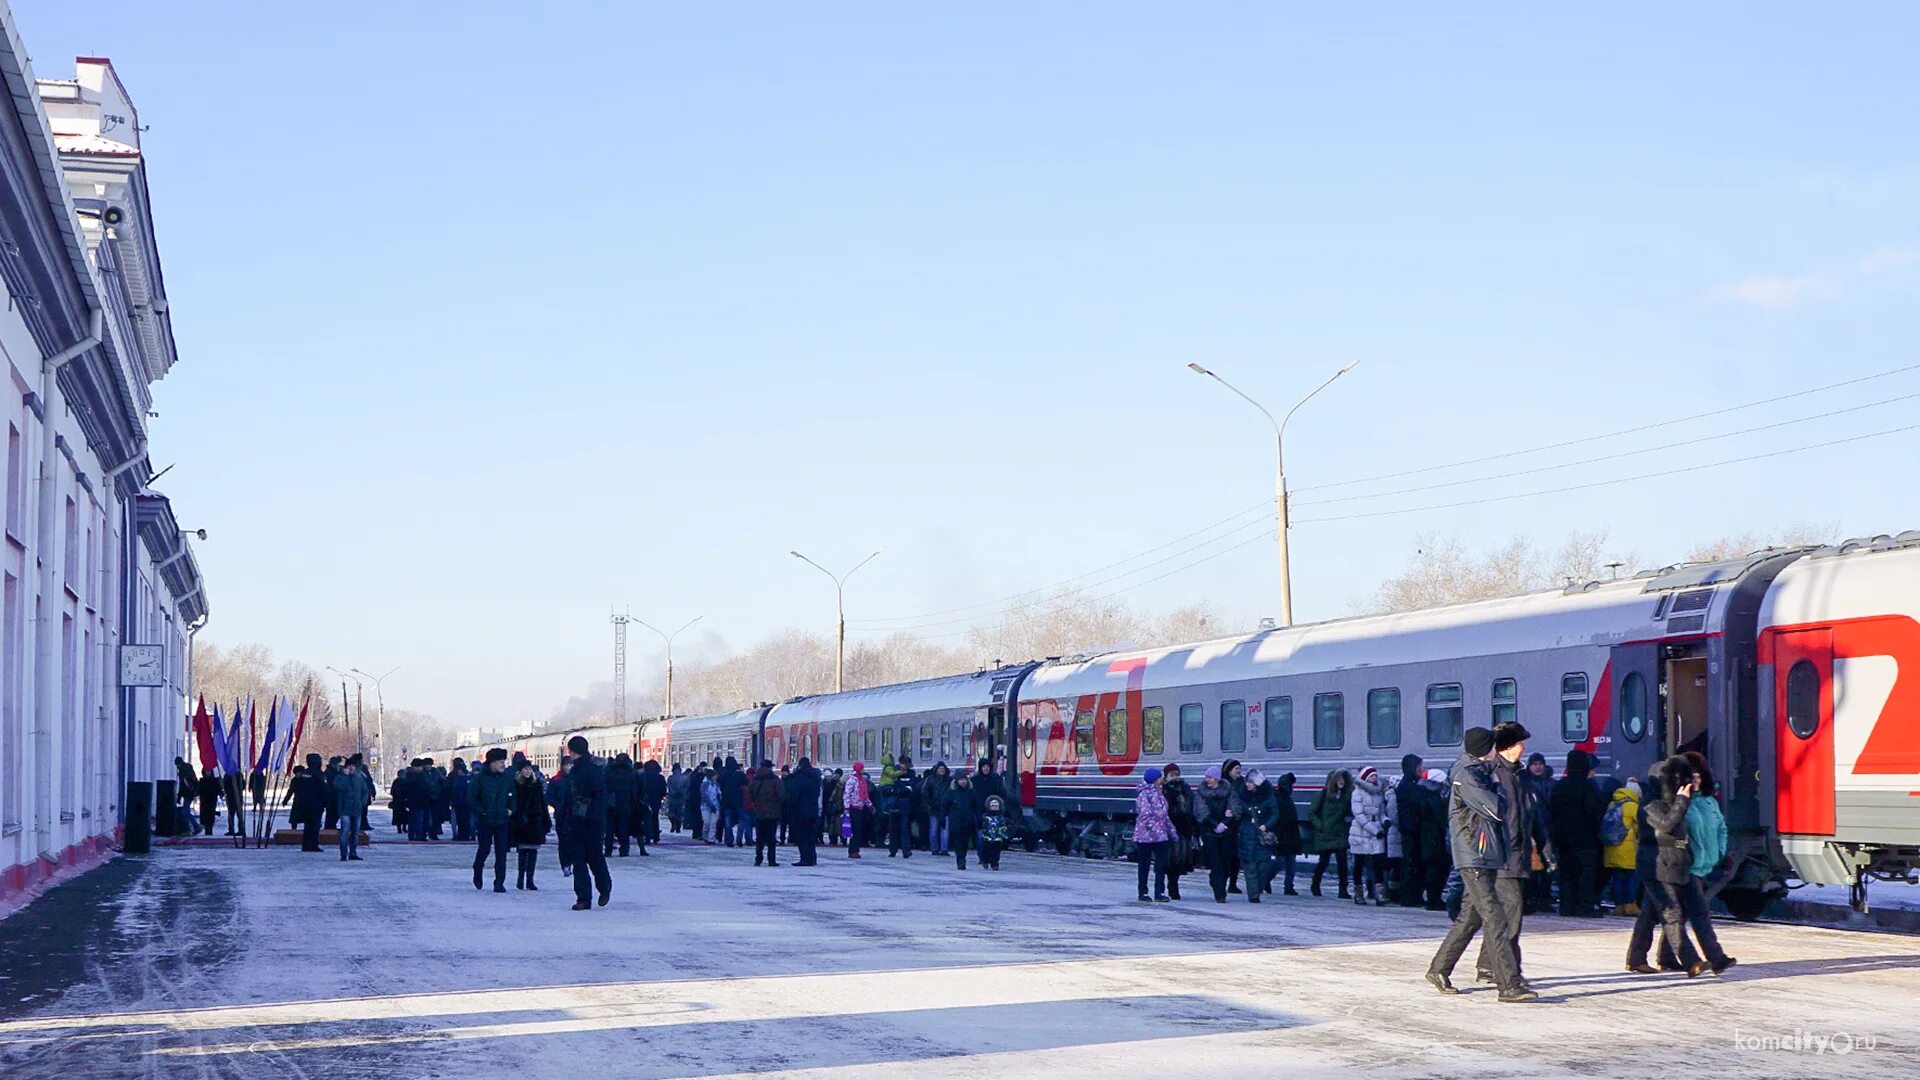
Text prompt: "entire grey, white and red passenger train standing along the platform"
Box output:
[[434, 530, 1920, 919]]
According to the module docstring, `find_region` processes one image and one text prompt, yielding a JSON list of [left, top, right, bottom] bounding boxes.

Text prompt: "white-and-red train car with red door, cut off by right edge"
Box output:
[[1753, 532, 1920, 909]]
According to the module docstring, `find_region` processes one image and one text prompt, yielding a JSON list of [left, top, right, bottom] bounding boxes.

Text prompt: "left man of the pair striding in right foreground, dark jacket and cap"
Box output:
[[1427, 728, 1538, 1003]]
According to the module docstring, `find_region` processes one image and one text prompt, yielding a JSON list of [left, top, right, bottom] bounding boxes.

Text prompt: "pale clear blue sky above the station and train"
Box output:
[[15, 0, 1920, 724]]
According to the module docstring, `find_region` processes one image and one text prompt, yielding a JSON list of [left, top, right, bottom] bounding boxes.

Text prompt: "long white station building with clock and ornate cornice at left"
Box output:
[[0, 10, 207, 901]]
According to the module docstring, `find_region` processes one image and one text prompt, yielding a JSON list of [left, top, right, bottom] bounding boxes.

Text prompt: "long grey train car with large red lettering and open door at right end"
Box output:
[[1018, 550, 1805, 896]]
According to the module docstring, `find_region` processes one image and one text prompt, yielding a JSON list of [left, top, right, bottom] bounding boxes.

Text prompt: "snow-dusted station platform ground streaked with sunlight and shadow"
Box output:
[[0, 810, 1920, 1080]]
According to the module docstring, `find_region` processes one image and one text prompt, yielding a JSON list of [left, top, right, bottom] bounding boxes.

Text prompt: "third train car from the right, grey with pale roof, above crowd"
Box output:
[[762, 663, 1037, 773]]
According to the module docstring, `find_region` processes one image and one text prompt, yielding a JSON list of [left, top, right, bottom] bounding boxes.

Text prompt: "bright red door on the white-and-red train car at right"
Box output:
[[1772, 630, 1834, 836]]
